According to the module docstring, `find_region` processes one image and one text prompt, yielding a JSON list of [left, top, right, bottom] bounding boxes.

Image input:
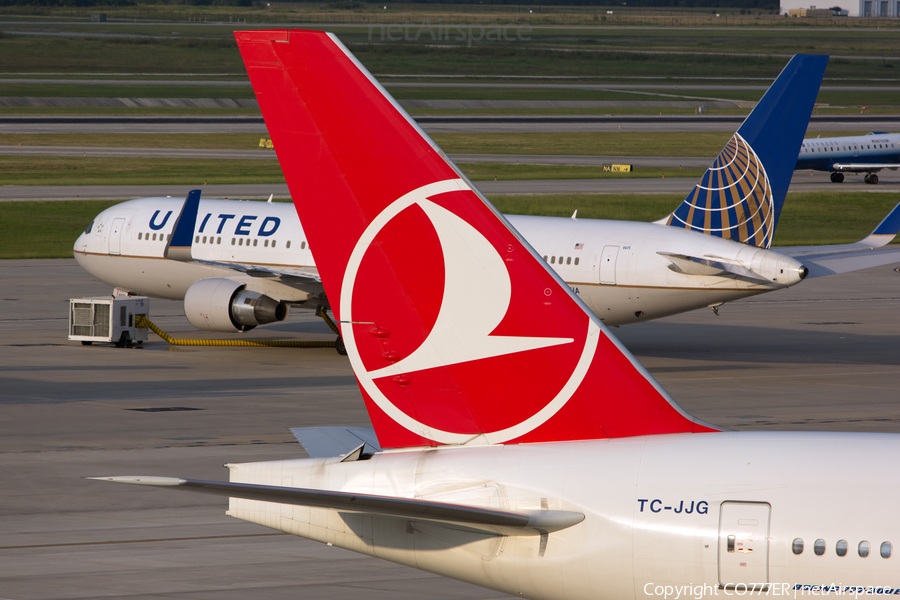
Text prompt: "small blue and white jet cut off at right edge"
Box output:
[[794, 131, 900, 185]]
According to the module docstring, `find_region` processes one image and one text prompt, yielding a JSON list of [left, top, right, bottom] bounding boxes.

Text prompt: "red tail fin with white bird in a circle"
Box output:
[[235, 31, 714, 448]]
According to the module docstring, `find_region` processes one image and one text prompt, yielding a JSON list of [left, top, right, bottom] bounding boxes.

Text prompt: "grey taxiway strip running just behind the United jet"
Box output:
[[0, 171, 900, 202]]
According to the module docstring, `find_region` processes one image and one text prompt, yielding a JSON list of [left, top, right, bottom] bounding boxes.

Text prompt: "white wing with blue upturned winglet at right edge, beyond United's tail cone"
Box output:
[[777, 204, 900, 278]]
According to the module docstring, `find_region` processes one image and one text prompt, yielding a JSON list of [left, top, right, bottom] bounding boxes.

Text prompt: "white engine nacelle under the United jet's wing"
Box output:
[[184, 278, 288, 332]]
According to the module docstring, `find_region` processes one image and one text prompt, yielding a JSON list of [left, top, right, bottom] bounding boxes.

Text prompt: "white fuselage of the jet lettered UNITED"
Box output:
[[74, 198, 802, 325]]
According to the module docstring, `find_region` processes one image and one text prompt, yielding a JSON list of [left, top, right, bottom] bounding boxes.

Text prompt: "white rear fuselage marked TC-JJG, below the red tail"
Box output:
[[228, 432, 900, 600]]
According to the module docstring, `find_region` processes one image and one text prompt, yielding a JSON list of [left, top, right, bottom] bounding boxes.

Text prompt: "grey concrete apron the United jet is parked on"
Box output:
[[0, 260, 900, 600]]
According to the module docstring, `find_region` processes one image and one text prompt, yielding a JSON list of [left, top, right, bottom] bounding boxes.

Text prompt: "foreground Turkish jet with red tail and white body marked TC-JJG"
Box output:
[[97, 31, 900, 600]]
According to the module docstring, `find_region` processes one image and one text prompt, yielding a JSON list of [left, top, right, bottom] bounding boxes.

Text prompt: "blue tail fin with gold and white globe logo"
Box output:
[[664, 54, 828, 248]]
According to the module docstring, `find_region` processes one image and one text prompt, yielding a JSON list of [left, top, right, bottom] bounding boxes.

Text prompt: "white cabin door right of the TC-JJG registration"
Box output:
[[719, 502, 772, 590]]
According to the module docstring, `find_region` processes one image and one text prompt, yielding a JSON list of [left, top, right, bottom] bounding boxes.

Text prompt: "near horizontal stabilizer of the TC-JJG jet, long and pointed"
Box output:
[[88, 476, 584, 535]]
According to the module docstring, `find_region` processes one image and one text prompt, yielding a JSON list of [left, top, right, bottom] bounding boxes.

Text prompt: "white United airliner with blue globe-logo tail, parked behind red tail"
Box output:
[[73, 77, 900, 338]]
